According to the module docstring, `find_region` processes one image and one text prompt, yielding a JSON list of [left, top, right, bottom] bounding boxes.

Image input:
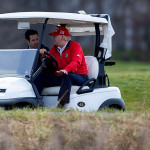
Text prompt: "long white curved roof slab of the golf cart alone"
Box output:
[[0, 12, 108, 27]]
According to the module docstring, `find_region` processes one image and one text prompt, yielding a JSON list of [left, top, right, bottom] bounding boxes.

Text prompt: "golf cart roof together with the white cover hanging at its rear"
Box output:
[[0, 11, 114, 59]]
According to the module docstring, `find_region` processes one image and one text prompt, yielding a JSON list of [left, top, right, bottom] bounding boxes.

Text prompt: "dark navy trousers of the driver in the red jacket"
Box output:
[[34, 72, 88, 106]]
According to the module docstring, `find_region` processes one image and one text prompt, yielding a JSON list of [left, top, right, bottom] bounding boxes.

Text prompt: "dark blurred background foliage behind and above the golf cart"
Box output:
[[0, 0, 150, 61]]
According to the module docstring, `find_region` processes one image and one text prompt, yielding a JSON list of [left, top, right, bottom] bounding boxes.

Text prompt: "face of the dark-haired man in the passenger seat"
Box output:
[[27, 34, 39, 49]]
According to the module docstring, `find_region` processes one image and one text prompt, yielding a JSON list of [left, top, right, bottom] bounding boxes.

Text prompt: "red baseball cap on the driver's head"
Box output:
[[49, 26, 69, 36]]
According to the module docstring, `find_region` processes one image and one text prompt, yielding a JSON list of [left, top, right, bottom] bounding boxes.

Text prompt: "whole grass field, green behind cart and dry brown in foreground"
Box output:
[[0, 61, 150, 150]]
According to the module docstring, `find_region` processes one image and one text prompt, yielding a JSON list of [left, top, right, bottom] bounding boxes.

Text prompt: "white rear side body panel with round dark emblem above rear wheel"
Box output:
[[66, 87, 121, 111]]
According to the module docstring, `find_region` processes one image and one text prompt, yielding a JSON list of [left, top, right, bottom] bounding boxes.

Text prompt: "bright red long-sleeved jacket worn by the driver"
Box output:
[[50, 41, 87, 75]]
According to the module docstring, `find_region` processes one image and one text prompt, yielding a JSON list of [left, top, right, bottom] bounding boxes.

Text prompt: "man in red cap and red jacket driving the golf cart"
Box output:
[[35, 26, 88, 106]]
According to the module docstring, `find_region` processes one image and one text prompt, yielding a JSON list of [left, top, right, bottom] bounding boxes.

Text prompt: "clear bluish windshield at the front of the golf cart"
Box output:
[[0, 49, 37, 77]]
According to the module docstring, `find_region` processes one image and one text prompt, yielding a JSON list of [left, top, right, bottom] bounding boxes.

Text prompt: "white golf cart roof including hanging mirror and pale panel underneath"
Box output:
[[0, 12, 108, 36]]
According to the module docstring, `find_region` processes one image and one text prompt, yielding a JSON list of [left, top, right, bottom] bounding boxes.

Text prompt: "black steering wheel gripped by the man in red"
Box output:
[[44, 51, 58, 73]]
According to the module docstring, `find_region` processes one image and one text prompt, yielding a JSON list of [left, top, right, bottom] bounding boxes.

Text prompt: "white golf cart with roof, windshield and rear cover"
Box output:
[[0, 12, 125, 111]]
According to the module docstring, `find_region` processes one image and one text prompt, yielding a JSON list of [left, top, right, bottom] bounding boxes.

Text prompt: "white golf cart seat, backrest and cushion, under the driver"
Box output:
[[42, 56, 99, 96]]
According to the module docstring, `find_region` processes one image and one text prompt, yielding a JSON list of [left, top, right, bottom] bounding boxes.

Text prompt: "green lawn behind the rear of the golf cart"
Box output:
[[106, 61, 150, 111]]
